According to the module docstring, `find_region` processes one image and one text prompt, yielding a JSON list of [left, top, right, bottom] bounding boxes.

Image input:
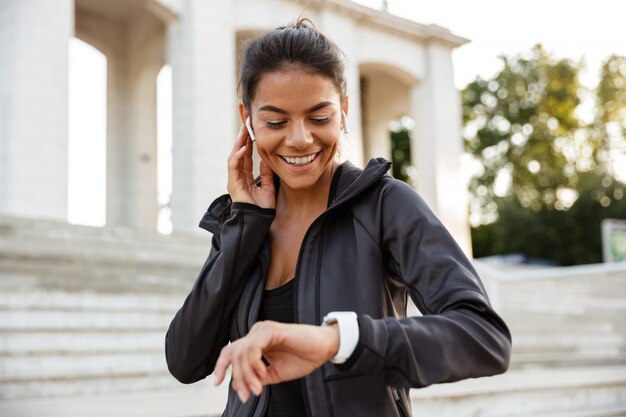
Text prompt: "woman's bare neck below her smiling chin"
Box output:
[[276, 163, 338, 218]]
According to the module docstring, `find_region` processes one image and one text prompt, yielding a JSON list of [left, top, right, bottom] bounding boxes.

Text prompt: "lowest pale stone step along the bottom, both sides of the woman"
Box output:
[[0, 367, 626, 417]]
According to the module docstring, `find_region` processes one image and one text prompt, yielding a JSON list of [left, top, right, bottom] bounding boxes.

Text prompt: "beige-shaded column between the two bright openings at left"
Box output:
[[107, 14, 165, 230]]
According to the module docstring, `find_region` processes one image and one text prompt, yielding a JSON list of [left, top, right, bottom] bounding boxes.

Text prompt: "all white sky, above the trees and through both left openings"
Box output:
[[68, 0, 626, 229]]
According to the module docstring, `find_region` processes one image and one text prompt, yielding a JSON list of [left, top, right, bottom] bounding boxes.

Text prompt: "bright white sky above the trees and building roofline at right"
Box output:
[[356, 0, 626, 89]]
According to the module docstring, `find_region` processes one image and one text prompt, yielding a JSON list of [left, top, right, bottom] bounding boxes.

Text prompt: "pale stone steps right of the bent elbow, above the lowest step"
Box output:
[[475, 261, 626, 369]]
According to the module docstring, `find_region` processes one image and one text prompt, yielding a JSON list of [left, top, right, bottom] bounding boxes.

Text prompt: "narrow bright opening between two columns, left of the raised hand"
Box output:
[[157, 65, 173, 234]]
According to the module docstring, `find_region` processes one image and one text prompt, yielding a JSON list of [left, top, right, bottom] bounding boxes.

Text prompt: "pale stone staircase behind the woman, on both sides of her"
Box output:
[[0, 217, 626, 417]]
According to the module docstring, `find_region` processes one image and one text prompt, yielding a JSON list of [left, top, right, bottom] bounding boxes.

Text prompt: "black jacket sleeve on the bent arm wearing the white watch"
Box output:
[[340, 180, 511, 387]]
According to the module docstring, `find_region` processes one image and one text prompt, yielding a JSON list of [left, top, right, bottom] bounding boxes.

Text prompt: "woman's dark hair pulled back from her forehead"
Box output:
[[239, 18, 346, 109]]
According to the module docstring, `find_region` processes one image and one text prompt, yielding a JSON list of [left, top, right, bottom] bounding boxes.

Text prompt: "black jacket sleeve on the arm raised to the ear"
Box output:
[[165, 203, 274, 384]]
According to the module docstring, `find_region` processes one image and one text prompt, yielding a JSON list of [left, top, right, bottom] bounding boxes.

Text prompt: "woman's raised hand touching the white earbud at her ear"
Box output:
[[227, 125, 276, 208]]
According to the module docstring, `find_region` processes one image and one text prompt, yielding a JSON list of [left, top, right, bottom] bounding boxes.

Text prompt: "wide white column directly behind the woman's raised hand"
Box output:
[[169, 0, 237, 231]]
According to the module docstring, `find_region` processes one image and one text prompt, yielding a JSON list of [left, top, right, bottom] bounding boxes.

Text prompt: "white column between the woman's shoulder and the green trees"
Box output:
[[411, 42, 471, 254]]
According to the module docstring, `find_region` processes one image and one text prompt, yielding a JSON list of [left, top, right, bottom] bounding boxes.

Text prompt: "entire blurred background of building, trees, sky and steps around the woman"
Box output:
[[0, 0, 626, 416]]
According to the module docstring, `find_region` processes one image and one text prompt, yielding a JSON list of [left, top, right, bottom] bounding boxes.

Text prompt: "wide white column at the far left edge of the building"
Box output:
[[0, 0, 74, 220]]
